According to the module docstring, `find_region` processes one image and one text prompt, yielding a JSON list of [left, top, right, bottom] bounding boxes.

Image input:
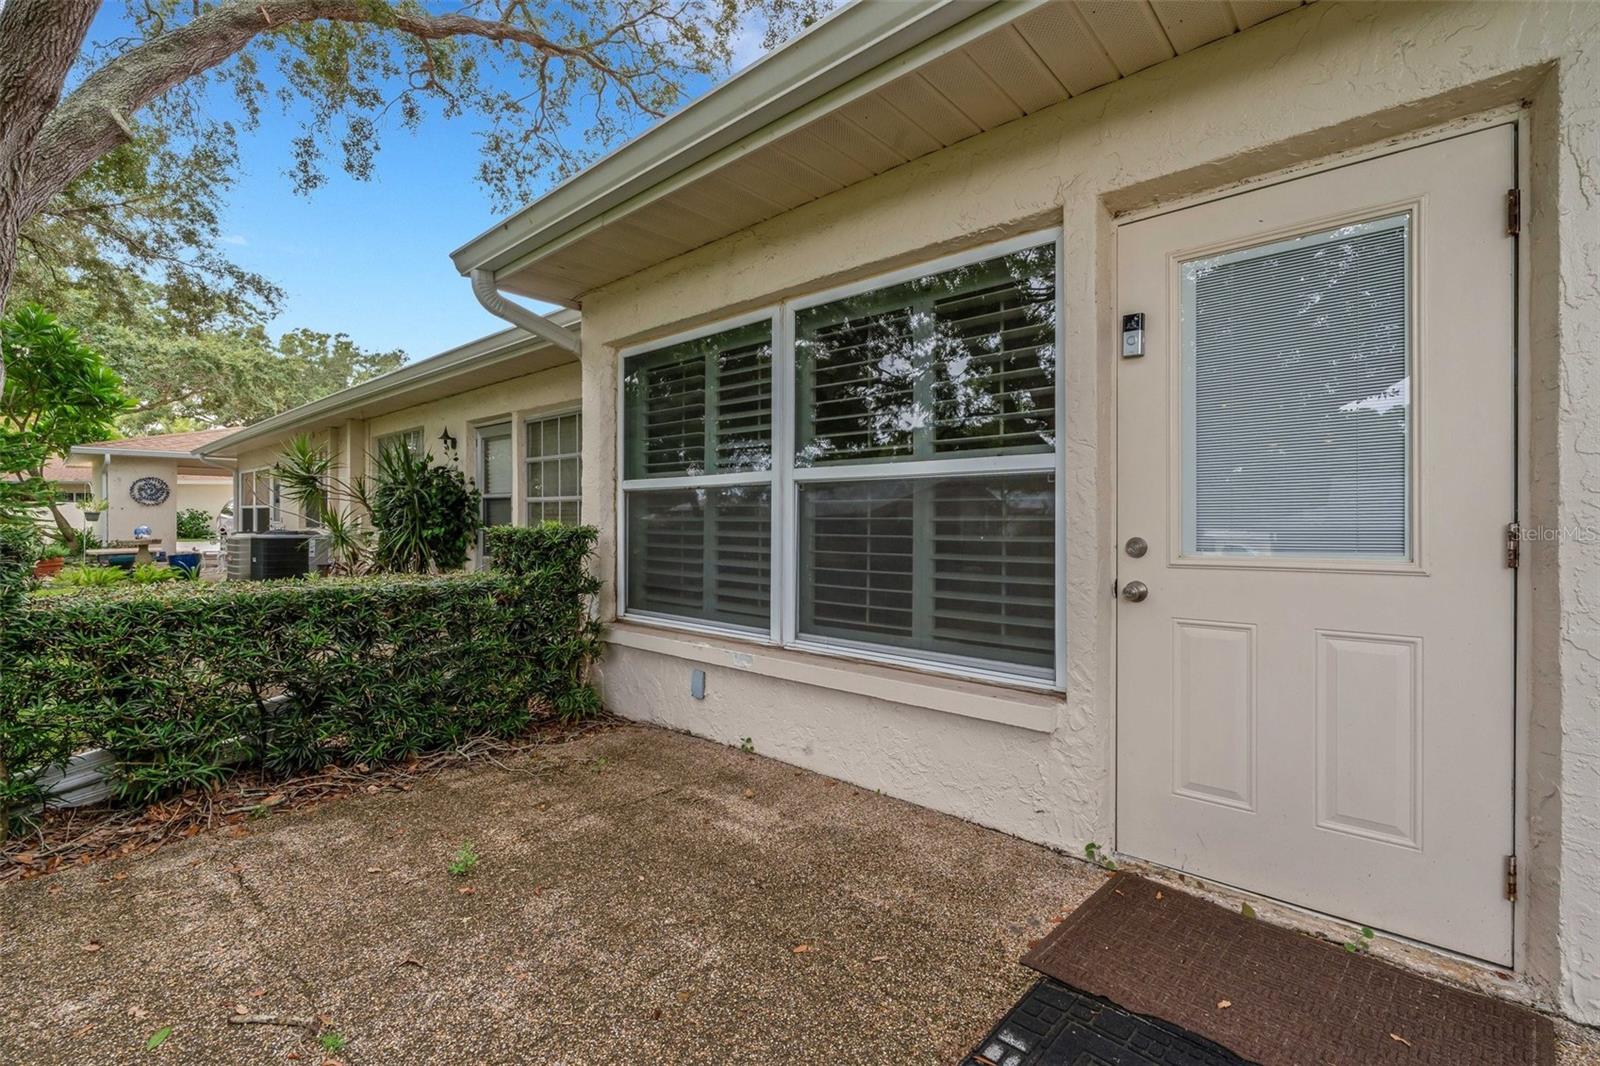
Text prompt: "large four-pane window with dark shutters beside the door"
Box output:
[[622, 235, 1062, 682]]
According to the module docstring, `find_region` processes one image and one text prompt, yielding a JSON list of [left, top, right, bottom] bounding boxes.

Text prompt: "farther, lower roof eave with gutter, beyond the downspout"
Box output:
[[200, 321, 578, 458]]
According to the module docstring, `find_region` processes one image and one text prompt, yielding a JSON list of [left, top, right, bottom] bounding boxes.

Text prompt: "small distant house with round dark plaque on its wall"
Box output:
[[72, 427, 234, 551]]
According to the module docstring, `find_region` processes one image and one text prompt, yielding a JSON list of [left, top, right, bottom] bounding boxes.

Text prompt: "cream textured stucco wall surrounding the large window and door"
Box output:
[[582, 0, 1600, 1021]]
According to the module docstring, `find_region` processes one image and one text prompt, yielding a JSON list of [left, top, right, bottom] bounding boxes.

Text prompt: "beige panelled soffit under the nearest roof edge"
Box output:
[[498, 0, 1309, 304]]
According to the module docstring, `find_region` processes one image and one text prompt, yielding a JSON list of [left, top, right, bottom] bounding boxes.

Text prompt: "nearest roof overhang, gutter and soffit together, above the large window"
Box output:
[[451, 0, 1309, 307]]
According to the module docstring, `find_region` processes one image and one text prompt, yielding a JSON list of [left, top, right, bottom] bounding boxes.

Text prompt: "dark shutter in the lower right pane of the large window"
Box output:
[[798, 474, 1056, 669]]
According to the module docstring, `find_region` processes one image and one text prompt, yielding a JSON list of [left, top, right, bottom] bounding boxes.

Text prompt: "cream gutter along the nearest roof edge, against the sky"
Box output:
[[451, 0, 1004, 274]]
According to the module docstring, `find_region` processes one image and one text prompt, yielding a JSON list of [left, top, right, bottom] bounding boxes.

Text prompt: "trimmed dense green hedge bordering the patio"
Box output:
[[0, 525, 600, 826]]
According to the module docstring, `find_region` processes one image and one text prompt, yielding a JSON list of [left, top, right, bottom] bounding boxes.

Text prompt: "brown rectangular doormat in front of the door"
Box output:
[[1022, 874, 1555, 1066]]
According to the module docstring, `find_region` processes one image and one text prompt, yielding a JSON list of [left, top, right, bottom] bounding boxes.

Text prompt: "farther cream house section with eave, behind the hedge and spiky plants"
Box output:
[[202, 323, 582, 555]]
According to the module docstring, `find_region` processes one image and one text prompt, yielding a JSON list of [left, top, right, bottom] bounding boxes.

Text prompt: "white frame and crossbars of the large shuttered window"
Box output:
[[616, 227, 1067, 691]]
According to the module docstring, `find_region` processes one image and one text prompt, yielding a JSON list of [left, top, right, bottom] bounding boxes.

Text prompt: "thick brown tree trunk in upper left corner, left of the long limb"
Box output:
[[0, 0, 99, 369]]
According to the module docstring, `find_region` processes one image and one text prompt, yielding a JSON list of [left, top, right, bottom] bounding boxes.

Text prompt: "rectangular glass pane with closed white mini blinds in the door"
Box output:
[[1179, 214, 1413, 562]]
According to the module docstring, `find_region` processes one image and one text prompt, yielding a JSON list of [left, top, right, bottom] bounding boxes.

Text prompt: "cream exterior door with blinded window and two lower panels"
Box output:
[[1117, 126, 1515, 964]]
